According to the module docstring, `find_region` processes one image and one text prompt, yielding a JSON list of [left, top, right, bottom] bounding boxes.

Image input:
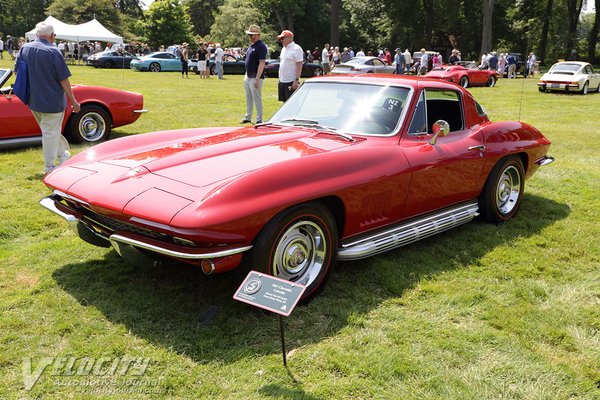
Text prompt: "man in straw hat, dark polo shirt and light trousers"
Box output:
[[242, 25, 267, 124]]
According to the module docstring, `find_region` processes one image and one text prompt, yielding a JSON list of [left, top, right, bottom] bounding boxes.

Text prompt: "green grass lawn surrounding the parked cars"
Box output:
[[0, 59, 600, 400]]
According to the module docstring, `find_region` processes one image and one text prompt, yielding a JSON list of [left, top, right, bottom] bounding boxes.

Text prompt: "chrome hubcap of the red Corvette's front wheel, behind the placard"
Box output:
[[273, 221, 327, 286]]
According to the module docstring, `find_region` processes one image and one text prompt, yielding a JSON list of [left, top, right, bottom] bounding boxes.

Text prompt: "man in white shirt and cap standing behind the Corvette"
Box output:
[[277, 30, 304, 103]]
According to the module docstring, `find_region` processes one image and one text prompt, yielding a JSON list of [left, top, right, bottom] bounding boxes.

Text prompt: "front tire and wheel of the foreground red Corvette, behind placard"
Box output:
[[244, 202, 338, 302]]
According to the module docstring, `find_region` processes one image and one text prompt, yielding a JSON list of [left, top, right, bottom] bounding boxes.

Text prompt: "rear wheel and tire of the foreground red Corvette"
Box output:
[[479, 156, 525, 224]]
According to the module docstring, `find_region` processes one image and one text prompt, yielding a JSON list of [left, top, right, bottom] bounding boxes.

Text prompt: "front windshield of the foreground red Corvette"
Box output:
[[269, 81, 410, 136]]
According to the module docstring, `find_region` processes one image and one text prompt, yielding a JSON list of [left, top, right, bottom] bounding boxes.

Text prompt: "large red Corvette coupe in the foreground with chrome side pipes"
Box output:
[[41, 74, 553, 300]]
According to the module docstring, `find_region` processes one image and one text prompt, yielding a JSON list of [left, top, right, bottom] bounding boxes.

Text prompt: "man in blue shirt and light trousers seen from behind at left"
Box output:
[[17, 22, 80, 173]]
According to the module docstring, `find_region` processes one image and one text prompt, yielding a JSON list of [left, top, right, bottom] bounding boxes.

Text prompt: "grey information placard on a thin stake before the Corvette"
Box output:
[[233, 271, 306, 317]]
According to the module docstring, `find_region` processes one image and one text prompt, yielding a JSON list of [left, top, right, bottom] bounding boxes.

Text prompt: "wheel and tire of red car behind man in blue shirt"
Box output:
[[65, 104, 112, 144]]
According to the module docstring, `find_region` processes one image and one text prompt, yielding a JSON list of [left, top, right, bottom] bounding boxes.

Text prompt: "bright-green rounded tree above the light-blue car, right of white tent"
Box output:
[[144, 0, 192, 48]]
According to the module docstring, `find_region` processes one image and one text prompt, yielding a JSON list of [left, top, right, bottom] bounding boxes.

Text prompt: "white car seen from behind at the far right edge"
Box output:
[[538, 61, 600, 94]]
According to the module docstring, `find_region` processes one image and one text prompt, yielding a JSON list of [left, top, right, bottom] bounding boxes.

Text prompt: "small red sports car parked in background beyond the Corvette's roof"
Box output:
[[425, 61, 498, 88]]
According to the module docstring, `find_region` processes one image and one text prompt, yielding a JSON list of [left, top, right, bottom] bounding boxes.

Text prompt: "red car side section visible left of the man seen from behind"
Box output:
[[0, 93, 41, 140]]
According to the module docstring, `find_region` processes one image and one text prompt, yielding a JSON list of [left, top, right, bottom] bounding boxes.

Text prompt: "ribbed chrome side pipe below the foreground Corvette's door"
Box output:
[[337, 202, 479, 261]]
